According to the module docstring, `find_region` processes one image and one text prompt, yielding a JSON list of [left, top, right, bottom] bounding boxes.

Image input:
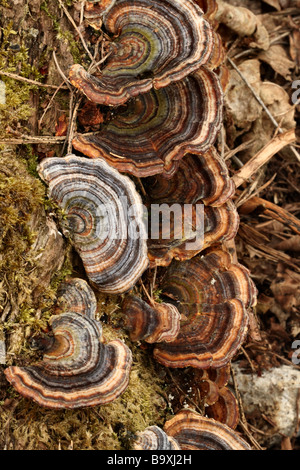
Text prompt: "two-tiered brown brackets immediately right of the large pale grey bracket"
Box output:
[[146, 148, 239, 266]]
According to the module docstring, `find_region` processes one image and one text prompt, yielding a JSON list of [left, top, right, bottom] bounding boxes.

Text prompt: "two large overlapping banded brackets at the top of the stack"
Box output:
[[69, 0, 223, 178]]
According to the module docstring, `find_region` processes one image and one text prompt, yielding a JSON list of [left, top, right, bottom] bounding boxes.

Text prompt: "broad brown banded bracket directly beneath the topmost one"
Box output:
[[73, 67, 224, 178]]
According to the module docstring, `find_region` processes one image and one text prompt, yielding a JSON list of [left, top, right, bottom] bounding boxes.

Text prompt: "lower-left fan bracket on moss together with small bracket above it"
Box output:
[[4, 280, 132, 409]]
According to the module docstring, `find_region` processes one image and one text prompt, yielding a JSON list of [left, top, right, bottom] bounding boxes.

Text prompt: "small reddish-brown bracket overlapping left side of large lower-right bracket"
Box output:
[[122, 295, 180, 343]]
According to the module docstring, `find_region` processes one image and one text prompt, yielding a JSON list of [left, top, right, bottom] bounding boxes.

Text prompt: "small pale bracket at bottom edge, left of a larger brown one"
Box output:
[[133, 426, 181, 450]]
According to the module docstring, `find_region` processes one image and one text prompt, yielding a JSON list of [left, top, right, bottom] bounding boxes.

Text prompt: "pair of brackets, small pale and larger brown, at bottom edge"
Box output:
[[133, 410, 251, 450]]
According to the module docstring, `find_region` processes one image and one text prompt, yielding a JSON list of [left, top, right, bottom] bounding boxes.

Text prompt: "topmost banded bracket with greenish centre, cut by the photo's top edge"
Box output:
[[69, 0, 214, 106]]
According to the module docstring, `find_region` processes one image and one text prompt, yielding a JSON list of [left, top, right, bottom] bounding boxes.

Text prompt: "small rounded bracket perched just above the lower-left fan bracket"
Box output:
[[55, 278, 97, 318]]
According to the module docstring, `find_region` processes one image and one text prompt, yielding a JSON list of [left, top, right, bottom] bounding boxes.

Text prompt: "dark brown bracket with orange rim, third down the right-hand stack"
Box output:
[[143, 147, 235, 207]]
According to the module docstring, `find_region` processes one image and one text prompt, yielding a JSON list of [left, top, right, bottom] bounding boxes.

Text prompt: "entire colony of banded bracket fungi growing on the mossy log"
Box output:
[[5, 0, 256, 450]]
